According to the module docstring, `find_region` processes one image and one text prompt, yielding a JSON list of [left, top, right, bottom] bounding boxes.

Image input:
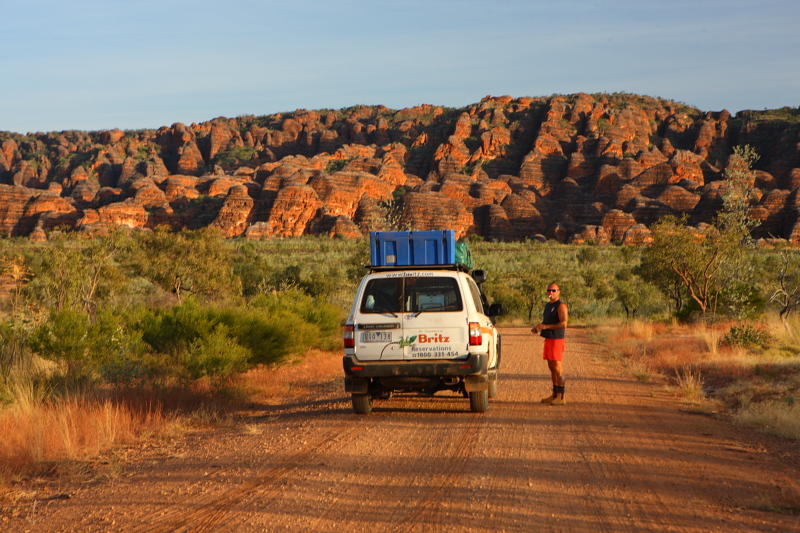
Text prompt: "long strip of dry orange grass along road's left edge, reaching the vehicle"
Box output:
[[0, 351, 341, 484]]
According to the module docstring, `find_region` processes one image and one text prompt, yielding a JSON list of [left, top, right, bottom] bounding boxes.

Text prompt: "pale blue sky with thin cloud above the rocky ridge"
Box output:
[[0, 0, 800, 134]]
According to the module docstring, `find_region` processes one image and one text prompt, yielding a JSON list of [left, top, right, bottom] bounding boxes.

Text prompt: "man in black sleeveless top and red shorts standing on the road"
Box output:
[[531, 283, 569, 405]]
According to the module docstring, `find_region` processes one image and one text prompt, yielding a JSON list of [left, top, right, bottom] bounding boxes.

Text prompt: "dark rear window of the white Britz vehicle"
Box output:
[[360, 276, 463, 313]]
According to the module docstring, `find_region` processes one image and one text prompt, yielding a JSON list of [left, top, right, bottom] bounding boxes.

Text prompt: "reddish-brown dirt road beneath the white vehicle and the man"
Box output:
[[6, 328, 800, 533]]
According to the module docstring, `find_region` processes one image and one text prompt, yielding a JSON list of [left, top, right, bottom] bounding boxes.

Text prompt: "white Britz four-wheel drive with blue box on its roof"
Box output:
[[343, 230, 502, 414]]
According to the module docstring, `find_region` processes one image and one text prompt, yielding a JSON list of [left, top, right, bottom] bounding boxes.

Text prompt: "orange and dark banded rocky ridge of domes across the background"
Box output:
[[0, 93, 800, 244]]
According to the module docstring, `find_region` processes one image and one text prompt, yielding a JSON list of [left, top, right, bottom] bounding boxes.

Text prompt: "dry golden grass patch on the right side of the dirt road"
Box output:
[[597, 323, 800, 439]]
